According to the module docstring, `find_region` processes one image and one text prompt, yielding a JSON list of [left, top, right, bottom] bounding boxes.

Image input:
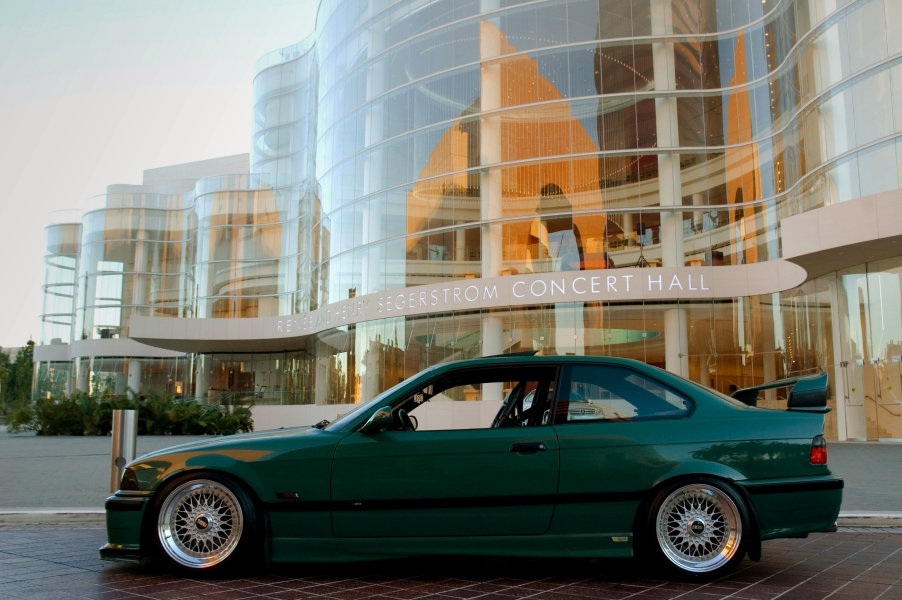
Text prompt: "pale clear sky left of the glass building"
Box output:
[[0, 0, 316, 348]]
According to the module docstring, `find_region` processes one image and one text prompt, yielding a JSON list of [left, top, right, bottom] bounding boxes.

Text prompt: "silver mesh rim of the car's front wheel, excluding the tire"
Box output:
[[157, 479, 244, 569]]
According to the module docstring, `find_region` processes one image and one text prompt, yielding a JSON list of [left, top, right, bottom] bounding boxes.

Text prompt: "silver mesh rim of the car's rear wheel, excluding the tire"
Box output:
[[655, 483, 742, 573]]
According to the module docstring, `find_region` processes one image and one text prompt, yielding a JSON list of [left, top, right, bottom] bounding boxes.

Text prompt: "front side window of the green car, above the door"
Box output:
[[392, 367, 557, 431]]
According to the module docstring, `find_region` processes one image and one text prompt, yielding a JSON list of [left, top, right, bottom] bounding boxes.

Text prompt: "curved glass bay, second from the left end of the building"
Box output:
[[73, 193, 195, 339]]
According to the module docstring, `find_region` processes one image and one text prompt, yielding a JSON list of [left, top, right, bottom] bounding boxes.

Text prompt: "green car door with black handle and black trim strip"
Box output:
[[332, 369, 559, 537]]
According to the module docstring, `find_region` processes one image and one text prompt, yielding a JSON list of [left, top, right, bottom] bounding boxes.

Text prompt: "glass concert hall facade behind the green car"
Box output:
[[33, 0, 902, 440]]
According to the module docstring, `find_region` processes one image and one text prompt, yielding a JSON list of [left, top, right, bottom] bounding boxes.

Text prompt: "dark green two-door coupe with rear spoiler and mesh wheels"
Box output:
[[100, 355, 843, 576]]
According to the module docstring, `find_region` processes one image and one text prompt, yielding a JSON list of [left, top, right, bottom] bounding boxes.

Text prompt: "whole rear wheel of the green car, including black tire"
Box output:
[[648, 479, 750, 577]]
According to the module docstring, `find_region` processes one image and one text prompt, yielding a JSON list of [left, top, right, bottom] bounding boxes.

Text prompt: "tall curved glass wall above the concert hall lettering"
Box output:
[[317, 0, 902, 292]]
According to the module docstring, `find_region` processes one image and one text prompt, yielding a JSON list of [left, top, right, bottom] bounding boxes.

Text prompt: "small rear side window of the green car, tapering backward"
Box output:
[[554, 365, 691, 424]]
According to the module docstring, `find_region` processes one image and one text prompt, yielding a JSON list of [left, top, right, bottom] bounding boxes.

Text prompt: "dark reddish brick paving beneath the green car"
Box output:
[[0, 525, 902, 600]]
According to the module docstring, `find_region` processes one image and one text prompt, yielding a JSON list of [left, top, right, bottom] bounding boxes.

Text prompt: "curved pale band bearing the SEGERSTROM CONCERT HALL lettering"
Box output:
[[129, 259, 807, 352]]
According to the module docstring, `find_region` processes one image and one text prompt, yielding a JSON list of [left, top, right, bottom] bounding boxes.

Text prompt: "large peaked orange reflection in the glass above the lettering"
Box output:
[[407, 21, 605, 270]]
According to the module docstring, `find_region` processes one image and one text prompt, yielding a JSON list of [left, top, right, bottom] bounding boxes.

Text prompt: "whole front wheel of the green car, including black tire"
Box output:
[[153, 474, 257, 572]]
